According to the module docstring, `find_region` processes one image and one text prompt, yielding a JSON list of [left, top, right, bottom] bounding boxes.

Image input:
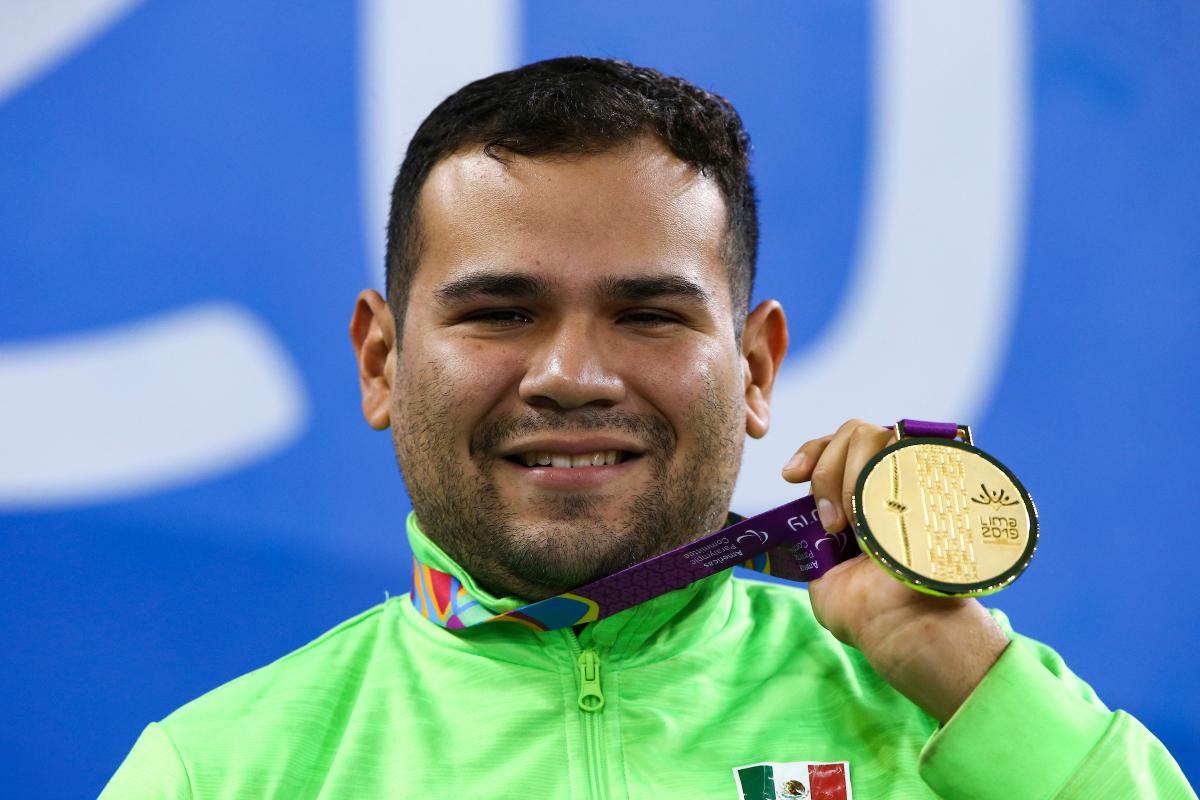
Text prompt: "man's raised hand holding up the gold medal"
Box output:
[[784, 420, 1008, 722]]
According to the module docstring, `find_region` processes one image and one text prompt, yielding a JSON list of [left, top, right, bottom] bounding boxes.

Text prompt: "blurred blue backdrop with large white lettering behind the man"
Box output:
[[0, 0, 1200, 798]]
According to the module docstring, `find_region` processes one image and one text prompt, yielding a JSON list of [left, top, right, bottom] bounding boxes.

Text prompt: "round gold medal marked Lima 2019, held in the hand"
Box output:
[[853, 420, 1038, 597]]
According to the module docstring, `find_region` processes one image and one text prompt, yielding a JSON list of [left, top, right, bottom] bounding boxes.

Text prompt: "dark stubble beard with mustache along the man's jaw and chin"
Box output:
[[392, 362, 744, 601]]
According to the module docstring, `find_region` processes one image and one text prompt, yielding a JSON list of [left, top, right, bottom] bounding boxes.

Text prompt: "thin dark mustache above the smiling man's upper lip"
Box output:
[[470, 408, 676, 456]]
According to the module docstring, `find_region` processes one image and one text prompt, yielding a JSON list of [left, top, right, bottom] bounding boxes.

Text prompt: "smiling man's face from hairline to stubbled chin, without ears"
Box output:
[[389, 138, 746, 600]]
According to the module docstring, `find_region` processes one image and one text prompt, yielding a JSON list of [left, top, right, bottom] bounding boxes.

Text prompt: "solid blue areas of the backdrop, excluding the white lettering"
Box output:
[[0, 0, 1200, 798]]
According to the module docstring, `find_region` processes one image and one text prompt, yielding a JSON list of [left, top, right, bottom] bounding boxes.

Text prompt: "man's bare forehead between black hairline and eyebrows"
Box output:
[[413, 138, 728, 297]]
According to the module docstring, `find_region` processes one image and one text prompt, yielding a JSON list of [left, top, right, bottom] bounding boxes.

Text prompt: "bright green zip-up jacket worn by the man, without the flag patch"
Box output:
[[101, 515, 1195, 800]]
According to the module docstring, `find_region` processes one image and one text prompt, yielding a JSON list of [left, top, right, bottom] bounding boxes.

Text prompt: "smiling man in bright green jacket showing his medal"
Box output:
[[104, 58, 1194, 799]]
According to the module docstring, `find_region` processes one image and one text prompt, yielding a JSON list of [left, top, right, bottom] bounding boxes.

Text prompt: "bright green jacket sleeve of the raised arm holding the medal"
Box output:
[[919, 619, 1196, 800]]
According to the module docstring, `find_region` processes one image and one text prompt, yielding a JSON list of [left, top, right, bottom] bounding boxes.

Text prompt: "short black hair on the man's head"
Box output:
[[386, 56, 758, 336]]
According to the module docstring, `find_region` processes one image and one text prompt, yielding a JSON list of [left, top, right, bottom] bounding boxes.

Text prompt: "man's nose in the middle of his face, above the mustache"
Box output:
[[520, 318, 625, 409]]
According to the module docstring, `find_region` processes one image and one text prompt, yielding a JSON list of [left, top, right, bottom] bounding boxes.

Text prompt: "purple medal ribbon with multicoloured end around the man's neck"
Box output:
[[413, 497, 860, 631]]
